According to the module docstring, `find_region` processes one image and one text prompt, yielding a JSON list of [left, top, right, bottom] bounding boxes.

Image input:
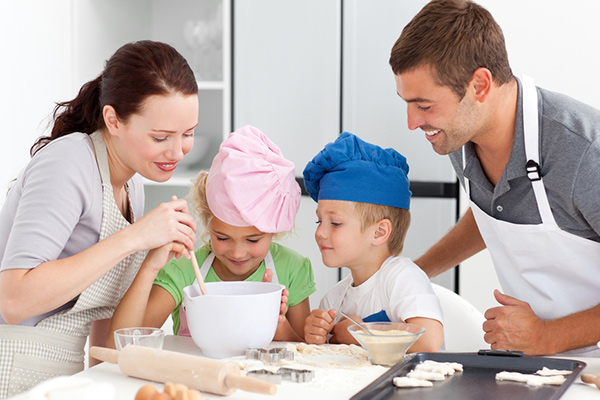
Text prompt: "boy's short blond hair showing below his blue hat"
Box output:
[[351, 201, 410, 256]]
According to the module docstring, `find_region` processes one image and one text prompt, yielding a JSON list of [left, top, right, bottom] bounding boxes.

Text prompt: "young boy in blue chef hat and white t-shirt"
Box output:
[[304, 132, 444, 352]]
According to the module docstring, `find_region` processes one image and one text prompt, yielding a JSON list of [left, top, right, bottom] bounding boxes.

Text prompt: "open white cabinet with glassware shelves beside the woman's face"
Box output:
[[137, 0, 231, 211]]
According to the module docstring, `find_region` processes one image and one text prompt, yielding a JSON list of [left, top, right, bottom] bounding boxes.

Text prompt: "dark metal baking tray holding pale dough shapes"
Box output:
[[351, 350, 586, 400]]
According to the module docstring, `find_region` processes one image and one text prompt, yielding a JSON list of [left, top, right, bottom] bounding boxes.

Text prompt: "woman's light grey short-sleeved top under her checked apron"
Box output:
[[0, 133, 144, 325]]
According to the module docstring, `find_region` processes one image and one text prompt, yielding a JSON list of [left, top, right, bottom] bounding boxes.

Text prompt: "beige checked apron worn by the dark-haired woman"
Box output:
[[0, 132, 145, 399]]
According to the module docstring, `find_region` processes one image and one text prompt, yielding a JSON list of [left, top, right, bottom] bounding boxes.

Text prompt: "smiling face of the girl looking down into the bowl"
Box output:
[[208, 217, 273, 281]]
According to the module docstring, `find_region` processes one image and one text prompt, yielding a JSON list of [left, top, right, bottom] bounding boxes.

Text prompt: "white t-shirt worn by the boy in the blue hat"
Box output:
[[320, 256, 443, 323]]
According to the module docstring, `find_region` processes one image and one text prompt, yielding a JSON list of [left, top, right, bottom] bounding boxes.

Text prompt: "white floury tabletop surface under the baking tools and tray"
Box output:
[[12, 335, 600, 400]]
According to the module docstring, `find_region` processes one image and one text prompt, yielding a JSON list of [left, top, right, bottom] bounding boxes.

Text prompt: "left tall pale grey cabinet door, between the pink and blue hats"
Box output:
[[232, 0, 342, 308]]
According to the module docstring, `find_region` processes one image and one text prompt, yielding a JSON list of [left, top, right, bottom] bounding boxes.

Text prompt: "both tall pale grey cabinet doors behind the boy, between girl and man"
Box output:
[[233, 0, 457, 308]]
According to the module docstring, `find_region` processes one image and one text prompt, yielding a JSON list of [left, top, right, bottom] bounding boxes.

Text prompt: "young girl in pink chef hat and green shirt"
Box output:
[[107, 126, 315, 347]]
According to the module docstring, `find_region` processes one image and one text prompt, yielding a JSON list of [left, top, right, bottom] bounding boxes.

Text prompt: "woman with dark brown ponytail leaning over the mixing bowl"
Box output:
[[0, 41, 198, 398]]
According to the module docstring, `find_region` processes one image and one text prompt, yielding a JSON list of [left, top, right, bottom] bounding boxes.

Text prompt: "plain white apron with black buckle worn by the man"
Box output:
[[463, 76, 600, 357]]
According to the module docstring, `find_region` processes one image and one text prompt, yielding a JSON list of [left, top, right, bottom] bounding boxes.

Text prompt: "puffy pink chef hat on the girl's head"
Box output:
[[206, 125, 300, 233]]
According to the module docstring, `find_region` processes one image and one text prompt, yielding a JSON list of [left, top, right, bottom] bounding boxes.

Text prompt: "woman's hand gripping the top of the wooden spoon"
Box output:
[[127, 199, 198, 252]]
